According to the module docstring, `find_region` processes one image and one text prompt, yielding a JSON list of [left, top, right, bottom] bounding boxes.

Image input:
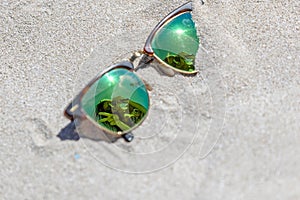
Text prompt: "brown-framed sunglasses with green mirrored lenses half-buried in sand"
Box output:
[[64, 2, 199, 142]]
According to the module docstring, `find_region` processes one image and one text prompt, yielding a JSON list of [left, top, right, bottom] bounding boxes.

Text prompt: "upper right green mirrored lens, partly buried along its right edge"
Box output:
[[151, 12, 199, 72]]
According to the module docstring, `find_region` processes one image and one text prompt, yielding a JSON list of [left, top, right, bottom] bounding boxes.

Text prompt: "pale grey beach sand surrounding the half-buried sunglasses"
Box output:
[[0, 0, 300, 200]]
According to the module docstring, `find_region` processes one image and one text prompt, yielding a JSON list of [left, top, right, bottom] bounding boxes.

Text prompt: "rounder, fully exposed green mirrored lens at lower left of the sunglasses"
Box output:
[[82, 68, 149, 133]]
